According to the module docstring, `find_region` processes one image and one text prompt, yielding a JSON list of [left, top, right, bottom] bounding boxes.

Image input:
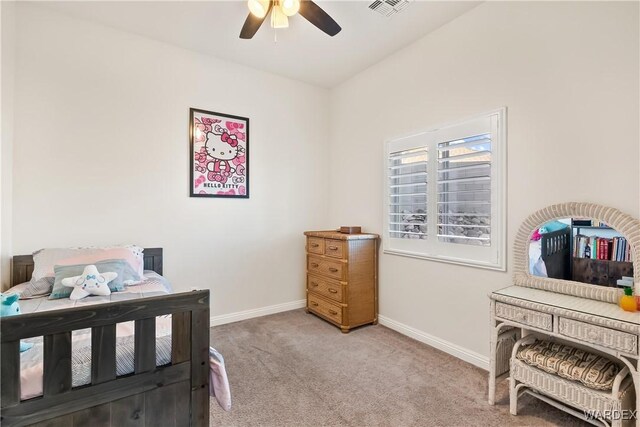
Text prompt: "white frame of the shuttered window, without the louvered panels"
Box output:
[[382, 107, 507, 271]]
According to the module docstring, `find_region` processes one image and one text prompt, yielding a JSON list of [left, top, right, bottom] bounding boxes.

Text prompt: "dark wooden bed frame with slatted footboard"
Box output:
[[0, 248, 209, 427]]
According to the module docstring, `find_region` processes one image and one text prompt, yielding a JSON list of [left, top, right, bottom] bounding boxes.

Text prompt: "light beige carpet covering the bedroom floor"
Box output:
[[211, 309, 588, 426]]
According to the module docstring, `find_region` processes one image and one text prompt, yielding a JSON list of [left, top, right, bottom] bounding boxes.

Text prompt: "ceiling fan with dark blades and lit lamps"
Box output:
[[240, 0, 342, 39]]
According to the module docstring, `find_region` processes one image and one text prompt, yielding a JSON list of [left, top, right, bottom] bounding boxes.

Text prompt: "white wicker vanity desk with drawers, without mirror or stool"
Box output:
[[489, 286, 640, 427]]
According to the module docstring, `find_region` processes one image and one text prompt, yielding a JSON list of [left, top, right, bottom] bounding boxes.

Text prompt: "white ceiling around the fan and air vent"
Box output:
[[37, 0, 479, 87]]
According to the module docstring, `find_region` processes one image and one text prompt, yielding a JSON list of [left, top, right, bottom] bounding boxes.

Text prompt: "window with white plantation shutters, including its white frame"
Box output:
[[384, 109, 506, 270]]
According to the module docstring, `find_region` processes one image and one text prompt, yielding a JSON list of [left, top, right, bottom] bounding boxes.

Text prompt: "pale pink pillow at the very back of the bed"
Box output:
[[32, 245, 144, 280]]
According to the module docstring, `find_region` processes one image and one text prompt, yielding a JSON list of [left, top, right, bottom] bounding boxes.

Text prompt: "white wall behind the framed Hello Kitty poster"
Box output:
[[13, 4, 329, 315]]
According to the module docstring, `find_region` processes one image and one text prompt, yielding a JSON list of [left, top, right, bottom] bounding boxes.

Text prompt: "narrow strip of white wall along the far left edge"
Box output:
[[0, 1, 15, 289]]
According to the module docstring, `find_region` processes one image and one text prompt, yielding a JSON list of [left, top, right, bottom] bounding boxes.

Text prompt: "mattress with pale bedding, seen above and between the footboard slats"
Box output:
[[11, 271, 171, 400]]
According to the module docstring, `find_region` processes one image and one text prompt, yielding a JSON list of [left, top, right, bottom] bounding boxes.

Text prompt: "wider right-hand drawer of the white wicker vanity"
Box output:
[[558, 317, 638, 354]]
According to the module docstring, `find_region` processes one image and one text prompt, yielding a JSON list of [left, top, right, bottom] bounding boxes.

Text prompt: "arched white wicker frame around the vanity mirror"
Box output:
[[513, 202, 640, 303]]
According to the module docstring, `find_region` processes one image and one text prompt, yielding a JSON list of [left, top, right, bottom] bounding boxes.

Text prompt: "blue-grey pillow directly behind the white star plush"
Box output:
[[49, 259, 138, 299]]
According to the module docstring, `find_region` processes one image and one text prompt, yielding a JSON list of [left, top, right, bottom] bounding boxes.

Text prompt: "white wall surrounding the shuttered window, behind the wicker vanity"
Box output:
[[330, 2, 640, 364]]
